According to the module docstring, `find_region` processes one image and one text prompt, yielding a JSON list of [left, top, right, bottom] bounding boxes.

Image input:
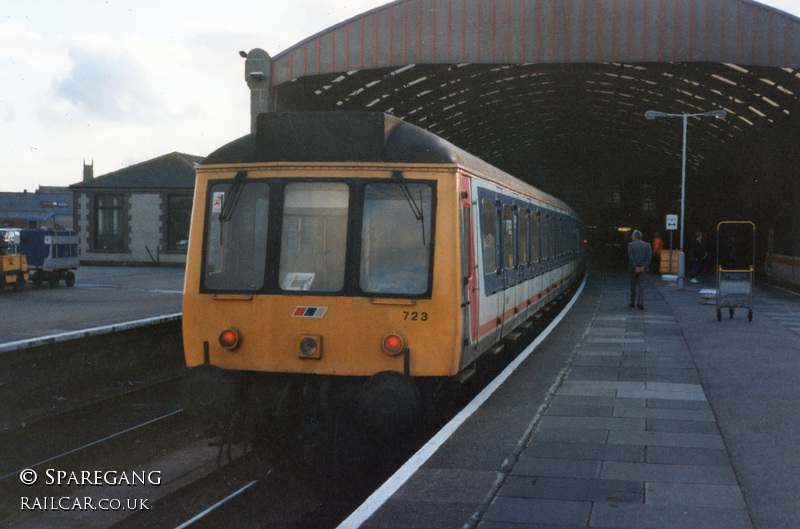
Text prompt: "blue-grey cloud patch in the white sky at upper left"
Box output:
[[54, 48, 156, 122]]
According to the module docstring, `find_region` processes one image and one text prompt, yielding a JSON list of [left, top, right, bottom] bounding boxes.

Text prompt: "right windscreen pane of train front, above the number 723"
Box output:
[[360, 183, 433, 294]]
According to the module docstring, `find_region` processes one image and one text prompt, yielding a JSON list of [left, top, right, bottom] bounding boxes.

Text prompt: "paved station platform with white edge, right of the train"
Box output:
[[340, 271, 800, 529]]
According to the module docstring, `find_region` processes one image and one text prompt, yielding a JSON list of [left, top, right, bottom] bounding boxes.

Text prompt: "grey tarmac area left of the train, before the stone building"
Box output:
[[0, 266, 183, 344]]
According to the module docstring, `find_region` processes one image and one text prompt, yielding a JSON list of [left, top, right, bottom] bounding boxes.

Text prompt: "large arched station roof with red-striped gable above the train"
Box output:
[[246, 0, 800, 235]]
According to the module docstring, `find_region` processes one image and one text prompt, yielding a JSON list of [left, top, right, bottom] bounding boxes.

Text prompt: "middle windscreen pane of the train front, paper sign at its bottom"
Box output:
[[278, 182, 350, 292]]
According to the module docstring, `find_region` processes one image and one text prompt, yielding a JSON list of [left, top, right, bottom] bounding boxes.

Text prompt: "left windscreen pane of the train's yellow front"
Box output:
[[205, 182, 269, 291]]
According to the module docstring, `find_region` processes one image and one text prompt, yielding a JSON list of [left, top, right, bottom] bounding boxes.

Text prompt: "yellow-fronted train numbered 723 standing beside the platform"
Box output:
[[183, 112, 578, 435]]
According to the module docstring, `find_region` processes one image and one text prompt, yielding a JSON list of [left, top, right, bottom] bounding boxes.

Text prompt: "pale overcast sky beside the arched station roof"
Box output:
[[0, 0, 800, 191]]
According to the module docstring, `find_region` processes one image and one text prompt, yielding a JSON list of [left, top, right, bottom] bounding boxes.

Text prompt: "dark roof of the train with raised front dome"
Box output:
[[200, 111, 574, 214]]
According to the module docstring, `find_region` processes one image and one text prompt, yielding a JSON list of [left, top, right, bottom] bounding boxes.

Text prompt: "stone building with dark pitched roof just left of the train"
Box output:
[[70, 152, 203, 266]]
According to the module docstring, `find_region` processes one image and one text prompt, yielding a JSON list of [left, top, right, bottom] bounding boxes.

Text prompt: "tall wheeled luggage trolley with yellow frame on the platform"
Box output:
[[717, 221, 756, 321]]
